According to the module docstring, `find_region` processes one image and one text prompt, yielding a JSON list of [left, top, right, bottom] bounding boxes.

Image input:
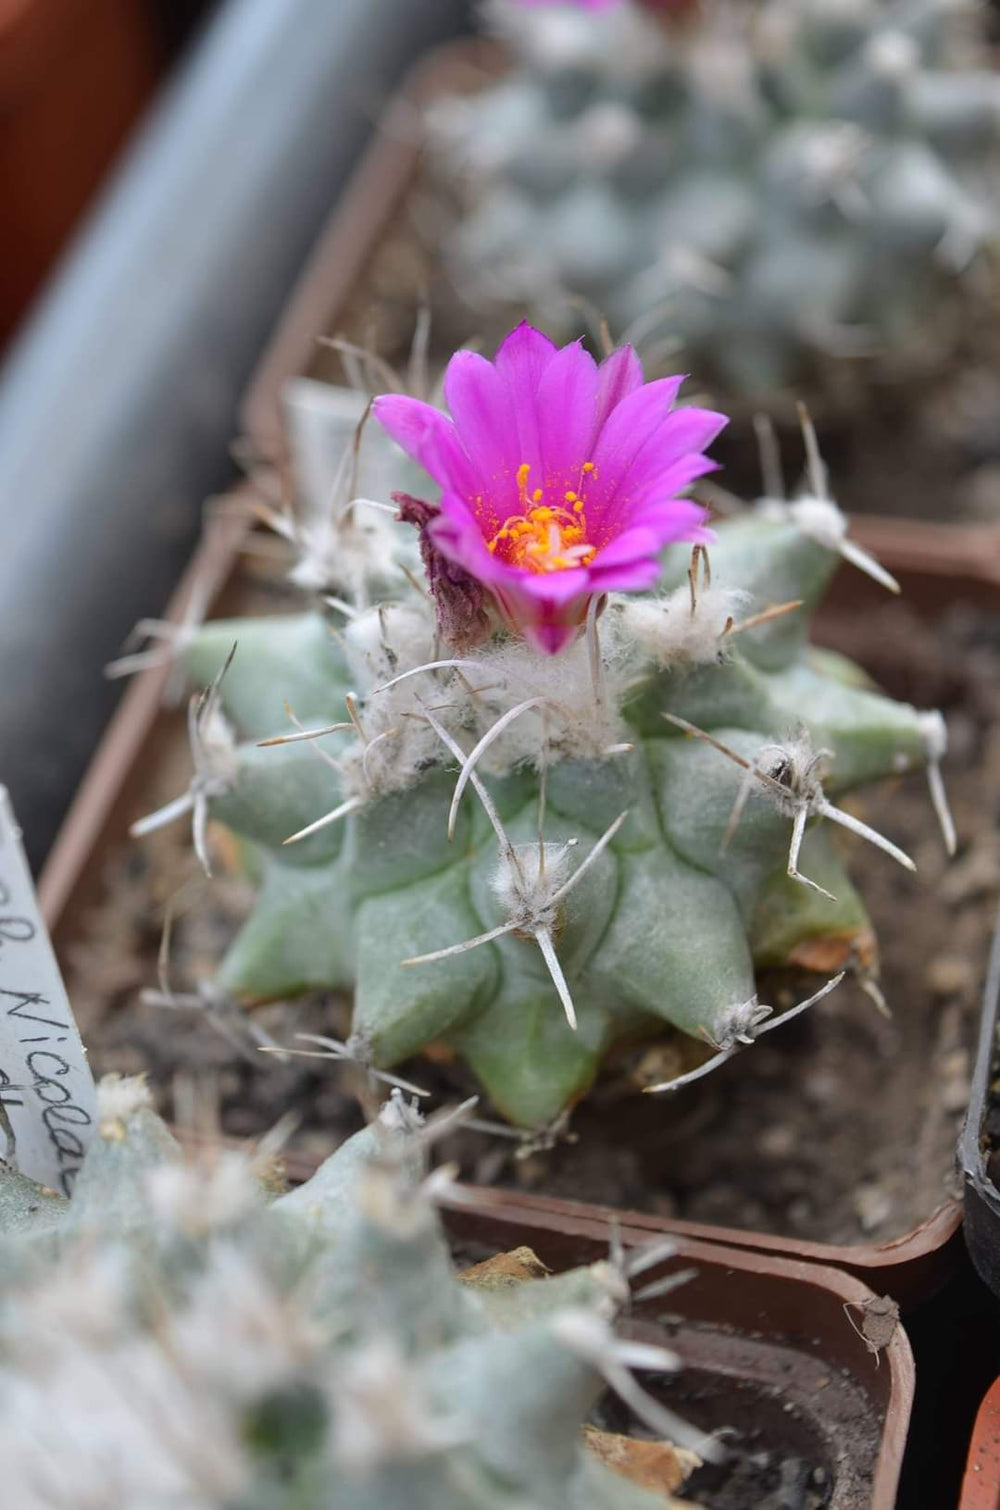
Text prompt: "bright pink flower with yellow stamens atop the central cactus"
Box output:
[[375, 322, 727, 654]]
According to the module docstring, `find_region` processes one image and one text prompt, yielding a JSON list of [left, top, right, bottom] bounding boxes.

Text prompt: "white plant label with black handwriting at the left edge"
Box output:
[[0, 787, 97, 1196]]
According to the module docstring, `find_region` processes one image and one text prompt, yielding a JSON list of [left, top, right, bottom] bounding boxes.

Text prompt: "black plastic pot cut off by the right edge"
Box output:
[[958, 899, 1000, 1296]]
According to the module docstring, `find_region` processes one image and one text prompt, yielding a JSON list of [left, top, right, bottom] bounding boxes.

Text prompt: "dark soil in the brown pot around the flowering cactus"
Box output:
[[62, 588, 1000, 1243]]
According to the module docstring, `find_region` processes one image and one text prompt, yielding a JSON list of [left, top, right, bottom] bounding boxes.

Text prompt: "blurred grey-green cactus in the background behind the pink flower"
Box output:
[[431, 0, 1000, 402]]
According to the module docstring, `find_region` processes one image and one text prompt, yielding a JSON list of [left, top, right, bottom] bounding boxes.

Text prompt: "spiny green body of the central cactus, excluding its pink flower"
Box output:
[[129, 374, 943, 1126]]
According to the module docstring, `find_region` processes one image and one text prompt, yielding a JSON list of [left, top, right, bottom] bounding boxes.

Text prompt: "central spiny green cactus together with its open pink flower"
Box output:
[[137, 328, 944, 1128]]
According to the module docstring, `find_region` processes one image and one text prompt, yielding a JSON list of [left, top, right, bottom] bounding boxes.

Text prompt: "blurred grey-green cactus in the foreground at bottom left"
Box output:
[[0, 1078, 703, 1510]]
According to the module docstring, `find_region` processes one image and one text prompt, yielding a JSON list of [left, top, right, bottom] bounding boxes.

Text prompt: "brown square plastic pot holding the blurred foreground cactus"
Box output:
[[446, 1191, 914, 1510]]
